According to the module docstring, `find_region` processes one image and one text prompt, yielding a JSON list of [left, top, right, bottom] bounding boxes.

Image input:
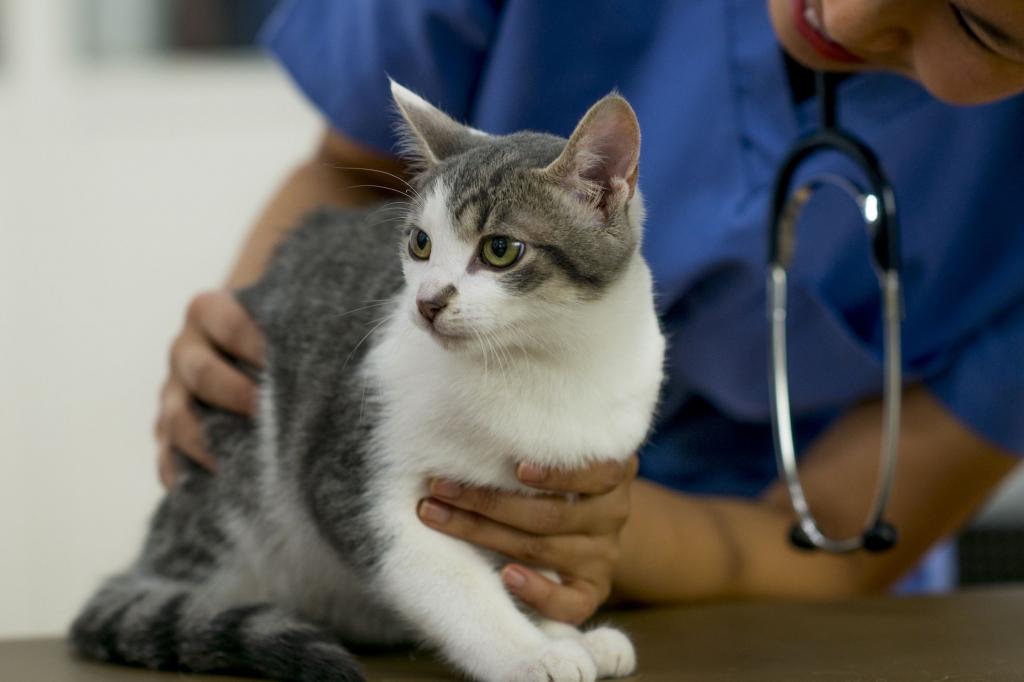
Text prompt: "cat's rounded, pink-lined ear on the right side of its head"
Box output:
[[542, 93, 640, 217]]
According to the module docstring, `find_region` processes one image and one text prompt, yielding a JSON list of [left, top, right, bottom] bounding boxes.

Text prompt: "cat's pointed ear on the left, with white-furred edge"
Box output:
[[391, 80, 487, 168]]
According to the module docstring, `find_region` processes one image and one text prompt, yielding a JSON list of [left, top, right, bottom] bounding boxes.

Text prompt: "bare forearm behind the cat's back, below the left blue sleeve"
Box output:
[[227, 133, 401, 288]]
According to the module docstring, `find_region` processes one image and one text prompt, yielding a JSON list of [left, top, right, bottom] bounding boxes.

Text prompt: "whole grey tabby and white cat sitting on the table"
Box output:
[[72, 84, 664, 682]]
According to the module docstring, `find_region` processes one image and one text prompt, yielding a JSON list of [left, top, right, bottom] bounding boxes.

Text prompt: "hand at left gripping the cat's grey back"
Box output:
[[156, 289, 263, 487]]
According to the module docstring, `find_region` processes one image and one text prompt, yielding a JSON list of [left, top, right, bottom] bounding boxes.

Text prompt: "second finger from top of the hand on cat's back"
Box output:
[[171, 335, 257, 415]]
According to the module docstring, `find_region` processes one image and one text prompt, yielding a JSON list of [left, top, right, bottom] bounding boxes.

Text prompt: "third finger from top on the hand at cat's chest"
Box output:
[[417, 500, 615, 572]]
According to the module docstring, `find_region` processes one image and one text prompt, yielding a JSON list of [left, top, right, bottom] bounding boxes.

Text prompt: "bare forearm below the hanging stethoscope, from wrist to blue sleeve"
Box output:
[[615, 387, 1016, 603]]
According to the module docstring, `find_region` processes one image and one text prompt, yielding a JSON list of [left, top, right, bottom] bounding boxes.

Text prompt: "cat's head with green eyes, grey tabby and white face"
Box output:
[[391, 82, 643, 349]]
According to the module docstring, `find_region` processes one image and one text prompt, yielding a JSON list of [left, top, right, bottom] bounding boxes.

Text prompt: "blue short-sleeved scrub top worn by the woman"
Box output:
[[264, 0, 1024, 496]]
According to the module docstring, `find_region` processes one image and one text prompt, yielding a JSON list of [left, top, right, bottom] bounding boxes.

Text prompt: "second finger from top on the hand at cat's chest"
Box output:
[[430, 479, 630, 536]]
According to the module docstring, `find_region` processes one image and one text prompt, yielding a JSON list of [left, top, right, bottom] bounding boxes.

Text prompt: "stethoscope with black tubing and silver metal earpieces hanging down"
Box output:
[[767, 73, 902, 553]]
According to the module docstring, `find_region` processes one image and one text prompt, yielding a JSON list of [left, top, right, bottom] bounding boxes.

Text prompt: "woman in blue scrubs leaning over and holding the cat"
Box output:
[[157, 0, 1024, 623]]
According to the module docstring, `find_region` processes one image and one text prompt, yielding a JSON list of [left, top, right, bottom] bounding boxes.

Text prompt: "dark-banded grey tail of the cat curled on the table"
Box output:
[[71, 573, 365, 682]]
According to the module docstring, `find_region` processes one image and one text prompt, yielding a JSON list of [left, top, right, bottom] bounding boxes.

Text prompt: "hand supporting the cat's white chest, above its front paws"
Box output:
[[418, 455, 638, 625]]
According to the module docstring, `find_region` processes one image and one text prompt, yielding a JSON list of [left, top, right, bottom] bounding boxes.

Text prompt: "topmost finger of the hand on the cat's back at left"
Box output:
[[186, 290, 264, 367]]
